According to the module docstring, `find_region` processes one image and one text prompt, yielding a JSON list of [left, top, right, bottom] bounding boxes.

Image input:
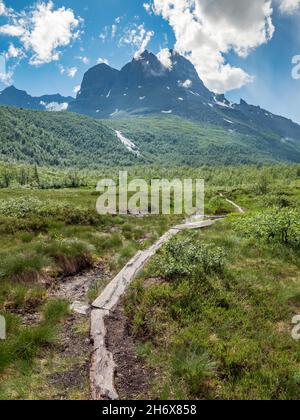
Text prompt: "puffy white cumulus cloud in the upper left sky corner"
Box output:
[[0, 0, 81, 65]]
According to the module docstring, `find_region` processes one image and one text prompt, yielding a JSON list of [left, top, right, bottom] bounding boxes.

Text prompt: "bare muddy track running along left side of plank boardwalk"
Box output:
[[47, 263, 110, 400]]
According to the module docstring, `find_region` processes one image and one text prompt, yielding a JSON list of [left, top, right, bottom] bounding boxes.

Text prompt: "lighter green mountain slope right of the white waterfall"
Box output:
[[109, 116, 300, 168]]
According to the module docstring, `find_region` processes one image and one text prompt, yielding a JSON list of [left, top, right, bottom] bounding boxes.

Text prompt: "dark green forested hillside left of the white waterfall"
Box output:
[[0, 106, 142, 168]]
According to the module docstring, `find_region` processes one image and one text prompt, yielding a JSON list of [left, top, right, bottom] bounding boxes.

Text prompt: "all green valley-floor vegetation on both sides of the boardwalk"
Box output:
[[0, 161, 300, 399]]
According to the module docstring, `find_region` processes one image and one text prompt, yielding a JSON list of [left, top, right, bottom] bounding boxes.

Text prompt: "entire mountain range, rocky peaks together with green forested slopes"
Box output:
[[0, 51, 300, 168]]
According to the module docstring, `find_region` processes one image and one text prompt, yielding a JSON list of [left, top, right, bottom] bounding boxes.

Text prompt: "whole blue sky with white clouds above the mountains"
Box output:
[[0, 0, 300, 122]]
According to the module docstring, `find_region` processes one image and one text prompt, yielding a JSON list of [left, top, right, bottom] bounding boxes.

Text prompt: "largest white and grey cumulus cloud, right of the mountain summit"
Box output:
[[153, 0, 274, 93]]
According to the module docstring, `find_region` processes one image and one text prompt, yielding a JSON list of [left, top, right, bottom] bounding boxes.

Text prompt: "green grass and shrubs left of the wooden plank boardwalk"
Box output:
[[0, 176, 178, 399]]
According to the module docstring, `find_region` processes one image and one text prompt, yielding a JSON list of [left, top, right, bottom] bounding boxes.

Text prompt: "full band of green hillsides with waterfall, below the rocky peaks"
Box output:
[[0, 106, 300, 169]]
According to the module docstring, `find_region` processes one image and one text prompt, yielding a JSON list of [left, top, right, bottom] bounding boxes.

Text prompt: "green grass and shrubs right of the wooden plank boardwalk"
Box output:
[[124, 168, 300, 400]]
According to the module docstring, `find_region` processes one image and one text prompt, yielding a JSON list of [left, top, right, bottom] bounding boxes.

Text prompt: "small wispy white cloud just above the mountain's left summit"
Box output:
[[119, 24, 154, 59]]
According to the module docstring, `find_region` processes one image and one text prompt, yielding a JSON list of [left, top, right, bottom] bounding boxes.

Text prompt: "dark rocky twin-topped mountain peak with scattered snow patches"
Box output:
[[68, 51, 300, 142]]
